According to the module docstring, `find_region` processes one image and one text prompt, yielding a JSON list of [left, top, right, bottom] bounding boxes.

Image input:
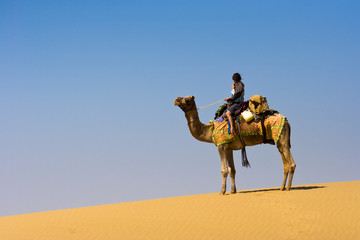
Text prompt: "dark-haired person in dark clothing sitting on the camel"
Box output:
[[224, 73, 245, 132]]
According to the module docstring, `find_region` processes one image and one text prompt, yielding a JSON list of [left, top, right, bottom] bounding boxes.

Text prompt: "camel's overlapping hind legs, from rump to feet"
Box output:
[[277, 121, 296, 191]]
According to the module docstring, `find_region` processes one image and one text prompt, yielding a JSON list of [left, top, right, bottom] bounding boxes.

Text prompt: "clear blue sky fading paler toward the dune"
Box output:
[[0, 0, 360, 216]]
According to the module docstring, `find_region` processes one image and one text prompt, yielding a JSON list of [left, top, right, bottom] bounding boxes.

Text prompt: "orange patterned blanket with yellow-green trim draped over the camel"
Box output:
[[212, 114, 286, 146]]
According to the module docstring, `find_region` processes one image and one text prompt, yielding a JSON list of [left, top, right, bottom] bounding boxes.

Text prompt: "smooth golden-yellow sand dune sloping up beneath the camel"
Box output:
[[0, 181, 360, 240]]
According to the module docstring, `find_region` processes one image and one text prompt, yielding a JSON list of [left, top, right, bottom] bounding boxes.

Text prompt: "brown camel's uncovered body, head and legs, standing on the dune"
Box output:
[[174, 96, 296, 195]]
